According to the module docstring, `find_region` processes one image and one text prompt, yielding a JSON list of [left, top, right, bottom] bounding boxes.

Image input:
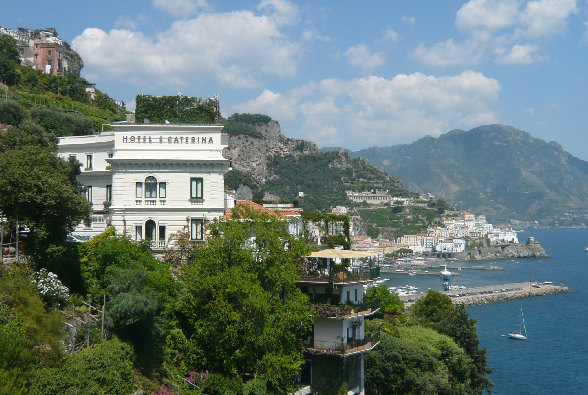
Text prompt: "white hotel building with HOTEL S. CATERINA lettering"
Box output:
[[58, 123, 233, 249]]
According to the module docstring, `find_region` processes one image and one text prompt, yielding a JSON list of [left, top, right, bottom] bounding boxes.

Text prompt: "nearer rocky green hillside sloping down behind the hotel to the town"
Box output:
[[220, 114, 409, 211]]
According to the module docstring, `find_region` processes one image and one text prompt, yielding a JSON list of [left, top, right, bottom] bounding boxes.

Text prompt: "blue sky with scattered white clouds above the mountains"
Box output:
[[0, 0, 588, 160]]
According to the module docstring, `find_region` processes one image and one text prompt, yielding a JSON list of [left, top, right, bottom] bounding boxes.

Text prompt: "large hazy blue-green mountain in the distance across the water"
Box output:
[[352, 125, 588, 226]]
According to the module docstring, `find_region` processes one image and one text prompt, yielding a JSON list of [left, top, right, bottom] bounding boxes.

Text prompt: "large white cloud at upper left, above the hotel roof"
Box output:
[[72, 8, 300, 89]]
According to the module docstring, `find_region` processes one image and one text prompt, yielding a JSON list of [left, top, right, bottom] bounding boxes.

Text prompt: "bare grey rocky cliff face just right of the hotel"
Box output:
[[225, 120, 318, 183]]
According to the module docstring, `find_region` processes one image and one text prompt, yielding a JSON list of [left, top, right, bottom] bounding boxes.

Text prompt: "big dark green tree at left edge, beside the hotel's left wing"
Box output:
[[0, 129, 90, 251]]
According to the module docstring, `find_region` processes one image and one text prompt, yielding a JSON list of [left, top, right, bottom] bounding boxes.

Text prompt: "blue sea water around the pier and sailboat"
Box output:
[[384, 229, 588, 395]]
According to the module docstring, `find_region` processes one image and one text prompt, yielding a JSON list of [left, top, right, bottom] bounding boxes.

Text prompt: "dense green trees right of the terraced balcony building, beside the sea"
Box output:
[[366, 286, 492, 394]]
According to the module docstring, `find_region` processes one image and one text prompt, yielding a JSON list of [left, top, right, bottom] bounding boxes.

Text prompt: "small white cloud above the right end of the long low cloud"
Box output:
[[411, 39, 484, 67]]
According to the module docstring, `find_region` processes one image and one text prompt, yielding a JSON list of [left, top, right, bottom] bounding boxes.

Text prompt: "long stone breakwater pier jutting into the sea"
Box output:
[[400, 281, 572, 307]]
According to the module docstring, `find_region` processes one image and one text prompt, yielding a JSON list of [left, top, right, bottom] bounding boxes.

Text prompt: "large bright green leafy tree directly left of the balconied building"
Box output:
[[168, 217, 312, 393]]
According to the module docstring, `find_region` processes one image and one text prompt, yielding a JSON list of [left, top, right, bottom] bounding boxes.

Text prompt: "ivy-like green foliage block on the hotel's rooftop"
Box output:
[[135, 94, 220, 124]]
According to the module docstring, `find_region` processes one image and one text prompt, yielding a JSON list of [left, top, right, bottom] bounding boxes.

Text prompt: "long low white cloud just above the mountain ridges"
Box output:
[[236, 71, 501, 149]]
